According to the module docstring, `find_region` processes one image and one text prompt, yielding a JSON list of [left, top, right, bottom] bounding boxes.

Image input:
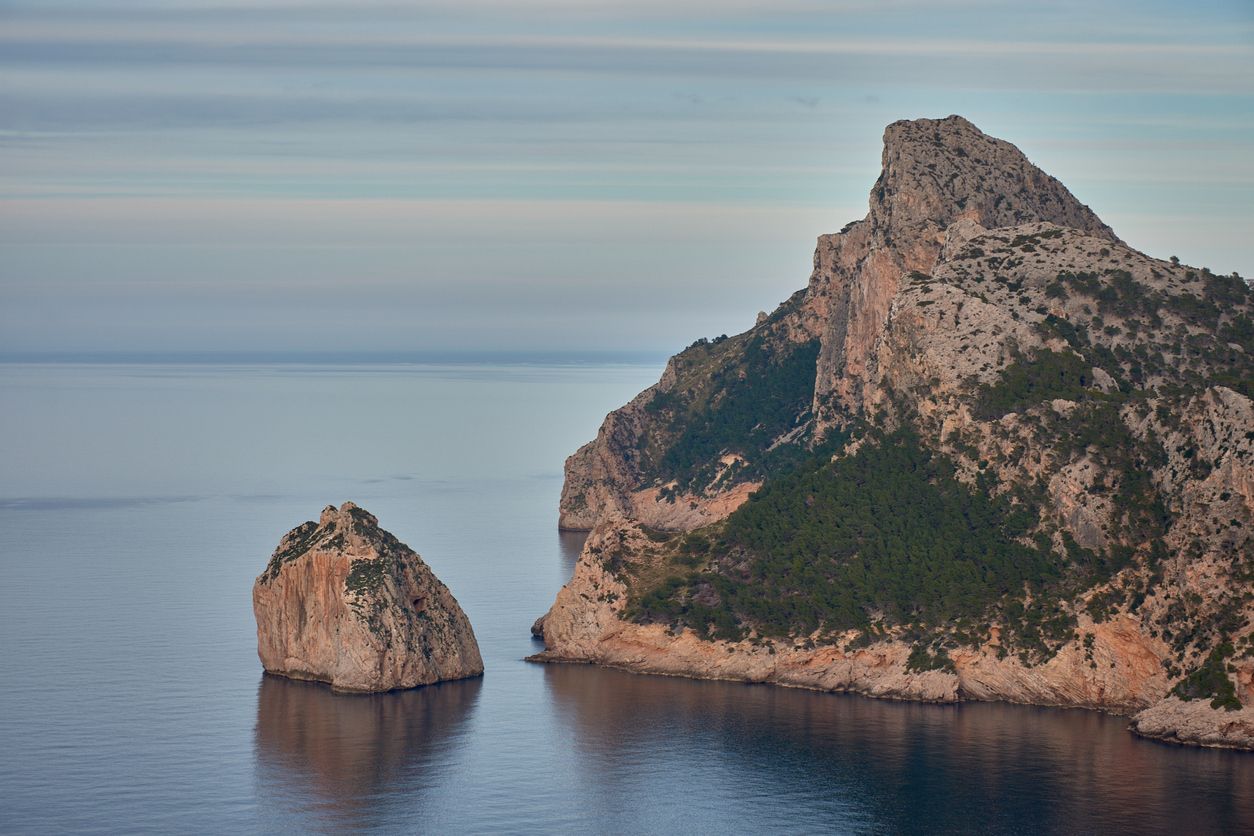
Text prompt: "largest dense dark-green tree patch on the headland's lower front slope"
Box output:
[[628, 430, 1073, 649]]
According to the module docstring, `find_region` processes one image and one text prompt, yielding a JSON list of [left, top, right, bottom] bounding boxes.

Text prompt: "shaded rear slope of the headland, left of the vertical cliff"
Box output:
[[558, 292, 823, 531]]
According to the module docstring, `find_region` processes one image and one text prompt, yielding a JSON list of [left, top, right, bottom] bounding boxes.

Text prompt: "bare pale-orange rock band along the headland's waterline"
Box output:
[[527, 518, 1254, 751]]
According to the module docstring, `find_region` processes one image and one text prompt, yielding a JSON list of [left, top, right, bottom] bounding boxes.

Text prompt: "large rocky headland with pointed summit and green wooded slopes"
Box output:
[[532, 117, 1254, 748]]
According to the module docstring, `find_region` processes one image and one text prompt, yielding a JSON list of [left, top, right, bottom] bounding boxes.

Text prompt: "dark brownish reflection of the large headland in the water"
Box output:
[[545, 666, 1254, 833]]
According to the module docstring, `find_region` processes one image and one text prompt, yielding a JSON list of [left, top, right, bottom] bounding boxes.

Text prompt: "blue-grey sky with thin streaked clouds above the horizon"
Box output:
[[0, 0, 1254, 357]]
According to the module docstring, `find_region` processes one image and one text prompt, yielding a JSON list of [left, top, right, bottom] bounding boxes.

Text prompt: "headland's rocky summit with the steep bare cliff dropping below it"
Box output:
[[808, 117, 1116, 427]]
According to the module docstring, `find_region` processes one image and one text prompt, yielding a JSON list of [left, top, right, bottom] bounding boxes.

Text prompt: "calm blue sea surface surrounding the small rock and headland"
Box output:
[[0, 365, 1254, 833]]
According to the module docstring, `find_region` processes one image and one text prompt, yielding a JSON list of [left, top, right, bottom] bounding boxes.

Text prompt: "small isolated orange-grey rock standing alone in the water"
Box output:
[[252, 503, 483, 693]]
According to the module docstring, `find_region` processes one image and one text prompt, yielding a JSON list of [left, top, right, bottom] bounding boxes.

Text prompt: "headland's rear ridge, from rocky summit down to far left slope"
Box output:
[[559, 117, 1116, 530]]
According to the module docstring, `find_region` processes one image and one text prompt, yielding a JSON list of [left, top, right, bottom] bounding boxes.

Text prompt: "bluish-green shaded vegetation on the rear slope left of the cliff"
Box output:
[[647, 337, 819, 488]]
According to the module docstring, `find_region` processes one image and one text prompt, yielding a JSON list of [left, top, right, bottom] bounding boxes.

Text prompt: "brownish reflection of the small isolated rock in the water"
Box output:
[[255, 676, 483, 827]]
